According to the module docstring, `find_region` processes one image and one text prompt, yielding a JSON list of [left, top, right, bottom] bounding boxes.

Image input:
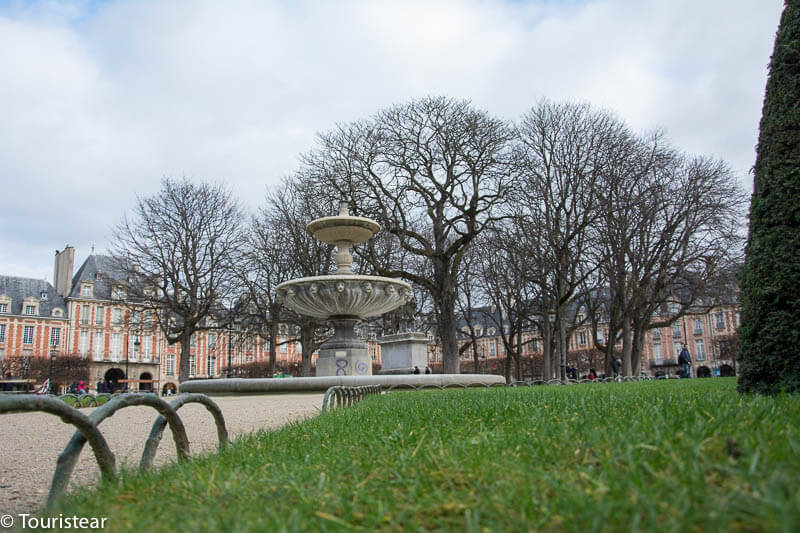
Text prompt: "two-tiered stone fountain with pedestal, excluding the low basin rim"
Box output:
[[277, 202, 411, 376]]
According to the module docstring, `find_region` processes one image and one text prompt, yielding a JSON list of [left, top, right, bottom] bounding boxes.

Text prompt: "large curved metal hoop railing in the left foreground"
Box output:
[[0, 393, 228, 506]]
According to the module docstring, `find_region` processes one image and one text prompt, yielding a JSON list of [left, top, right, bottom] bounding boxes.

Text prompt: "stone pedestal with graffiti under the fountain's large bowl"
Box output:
[[317, 316, 372, 376]]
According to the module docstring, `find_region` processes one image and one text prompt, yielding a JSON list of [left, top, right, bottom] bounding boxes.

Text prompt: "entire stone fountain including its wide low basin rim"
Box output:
[[180, 202, 505, 395]]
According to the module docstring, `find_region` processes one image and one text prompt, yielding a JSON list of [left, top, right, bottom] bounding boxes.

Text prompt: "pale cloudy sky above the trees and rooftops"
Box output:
[[0, 0, 783, 281]]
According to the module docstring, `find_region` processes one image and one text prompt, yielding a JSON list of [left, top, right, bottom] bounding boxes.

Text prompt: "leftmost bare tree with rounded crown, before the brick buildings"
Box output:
[[112, 178, 242, 381]]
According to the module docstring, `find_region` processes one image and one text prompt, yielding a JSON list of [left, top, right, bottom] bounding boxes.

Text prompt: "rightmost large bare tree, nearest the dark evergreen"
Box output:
[[597, 135, 743, 375]]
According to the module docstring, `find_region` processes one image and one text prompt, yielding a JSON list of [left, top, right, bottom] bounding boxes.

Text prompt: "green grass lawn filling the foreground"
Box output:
[[54, 379, 800, 532]]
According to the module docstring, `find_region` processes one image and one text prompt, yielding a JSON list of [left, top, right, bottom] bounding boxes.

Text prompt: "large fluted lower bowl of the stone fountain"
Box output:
[[276, 274, 411, 319]]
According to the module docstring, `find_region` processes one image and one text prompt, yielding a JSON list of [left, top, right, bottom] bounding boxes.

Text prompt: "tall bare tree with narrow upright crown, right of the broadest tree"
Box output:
[[516, 101, 627, 380]]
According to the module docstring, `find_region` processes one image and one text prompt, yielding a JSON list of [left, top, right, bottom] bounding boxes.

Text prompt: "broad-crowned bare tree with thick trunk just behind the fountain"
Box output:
[[303, 97, 513, 373]]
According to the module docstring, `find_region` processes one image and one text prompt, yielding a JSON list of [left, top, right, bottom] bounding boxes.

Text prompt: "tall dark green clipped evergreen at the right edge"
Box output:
[[739, 0, 800, 394]]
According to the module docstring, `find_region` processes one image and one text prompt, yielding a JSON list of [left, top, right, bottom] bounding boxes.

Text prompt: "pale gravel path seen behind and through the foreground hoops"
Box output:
[[0, 393, 323, 514]]
